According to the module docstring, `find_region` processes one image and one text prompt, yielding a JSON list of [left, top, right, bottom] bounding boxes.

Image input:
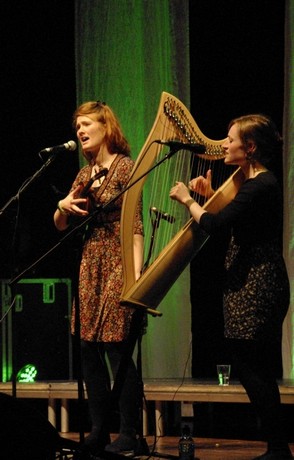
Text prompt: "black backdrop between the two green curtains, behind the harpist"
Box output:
[[190, 0, 285, 377]]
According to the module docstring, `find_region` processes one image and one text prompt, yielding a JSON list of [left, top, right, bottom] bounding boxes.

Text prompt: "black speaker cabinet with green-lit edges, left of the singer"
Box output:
[[1, 278, 73, 382]]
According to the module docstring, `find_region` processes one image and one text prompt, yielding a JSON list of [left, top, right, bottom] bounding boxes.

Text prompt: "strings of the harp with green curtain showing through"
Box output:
[[144, 147, 231, 267]]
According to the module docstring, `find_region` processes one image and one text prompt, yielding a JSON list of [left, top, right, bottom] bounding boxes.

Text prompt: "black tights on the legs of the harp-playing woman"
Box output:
[[227, 339, 287, 449]]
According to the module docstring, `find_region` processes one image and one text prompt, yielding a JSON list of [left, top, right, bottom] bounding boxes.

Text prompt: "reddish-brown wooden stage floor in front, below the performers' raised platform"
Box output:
[[61, 433, 294, 460]]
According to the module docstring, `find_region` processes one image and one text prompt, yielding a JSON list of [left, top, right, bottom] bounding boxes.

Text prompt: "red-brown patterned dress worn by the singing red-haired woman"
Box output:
[[72, 155, 143, 342]]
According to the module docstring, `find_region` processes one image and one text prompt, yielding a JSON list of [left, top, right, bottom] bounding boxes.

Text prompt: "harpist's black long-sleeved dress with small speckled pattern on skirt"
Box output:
[[200, 172, 289, 340]]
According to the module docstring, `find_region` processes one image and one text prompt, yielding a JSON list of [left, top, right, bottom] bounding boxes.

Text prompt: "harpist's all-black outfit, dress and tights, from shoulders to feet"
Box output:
[[200, 172, 292, 452]]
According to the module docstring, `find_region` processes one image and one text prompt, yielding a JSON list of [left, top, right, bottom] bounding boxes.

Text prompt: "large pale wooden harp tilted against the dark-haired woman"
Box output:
[[120, 92, 243, 314]]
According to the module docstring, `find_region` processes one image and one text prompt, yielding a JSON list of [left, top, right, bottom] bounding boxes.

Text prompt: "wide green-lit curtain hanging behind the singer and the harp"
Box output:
[[75, 0, 191, 378]]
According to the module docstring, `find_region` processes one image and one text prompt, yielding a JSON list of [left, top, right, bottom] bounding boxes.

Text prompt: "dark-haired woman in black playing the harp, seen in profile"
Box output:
[[170, 114, 293, 460]]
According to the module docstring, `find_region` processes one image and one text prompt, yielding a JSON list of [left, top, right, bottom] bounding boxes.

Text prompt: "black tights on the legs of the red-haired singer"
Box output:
[[81, 340, 140, 438]]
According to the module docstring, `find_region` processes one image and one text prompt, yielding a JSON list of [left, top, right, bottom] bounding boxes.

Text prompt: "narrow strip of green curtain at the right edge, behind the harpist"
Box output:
[[283, 0, 294, 379]]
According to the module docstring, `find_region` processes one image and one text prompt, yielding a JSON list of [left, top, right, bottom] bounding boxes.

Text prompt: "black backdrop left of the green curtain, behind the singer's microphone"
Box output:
[[0, 0, 78, 278]]
